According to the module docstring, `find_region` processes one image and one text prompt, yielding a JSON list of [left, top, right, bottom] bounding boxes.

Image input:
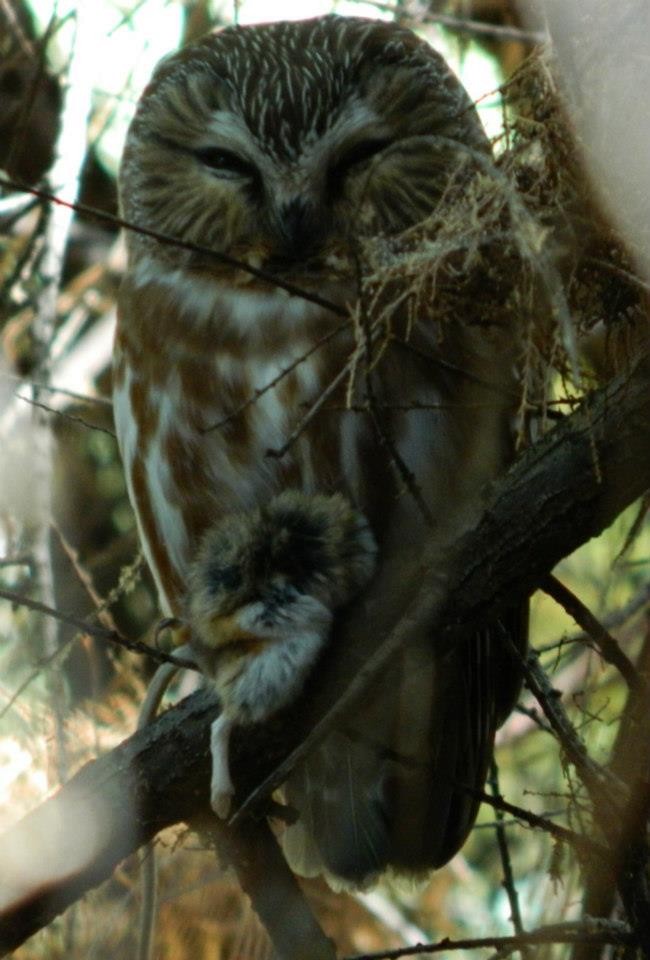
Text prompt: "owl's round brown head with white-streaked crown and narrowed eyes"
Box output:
[[120, 16, 487, 274]]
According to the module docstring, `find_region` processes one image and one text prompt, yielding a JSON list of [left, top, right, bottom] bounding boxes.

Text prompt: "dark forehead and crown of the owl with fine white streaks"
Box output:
[[150, 17, 418, 158]]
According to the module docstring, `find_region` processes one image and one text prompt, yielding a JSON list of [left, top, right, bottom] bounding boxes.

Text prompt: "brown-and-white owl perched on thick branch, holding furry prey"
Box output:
[[114, 16, 525, 883]]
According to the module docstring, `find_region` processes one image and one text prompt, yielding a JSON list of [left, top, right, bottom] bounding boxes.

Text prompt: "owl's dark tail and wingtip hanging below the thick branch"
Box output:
[[283, 604, 527, 886]]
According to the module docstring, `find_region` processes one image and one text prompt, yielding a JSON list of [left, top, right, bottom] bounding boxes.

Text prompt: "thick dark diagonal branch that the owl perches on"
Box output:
[[0, 358, 650, 952]]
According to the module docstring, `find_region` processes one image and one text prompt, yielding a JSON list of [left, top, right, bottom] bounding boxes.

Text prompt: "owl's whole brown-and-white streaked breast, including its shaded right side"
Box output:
[[114, 256, 509, 612]]
